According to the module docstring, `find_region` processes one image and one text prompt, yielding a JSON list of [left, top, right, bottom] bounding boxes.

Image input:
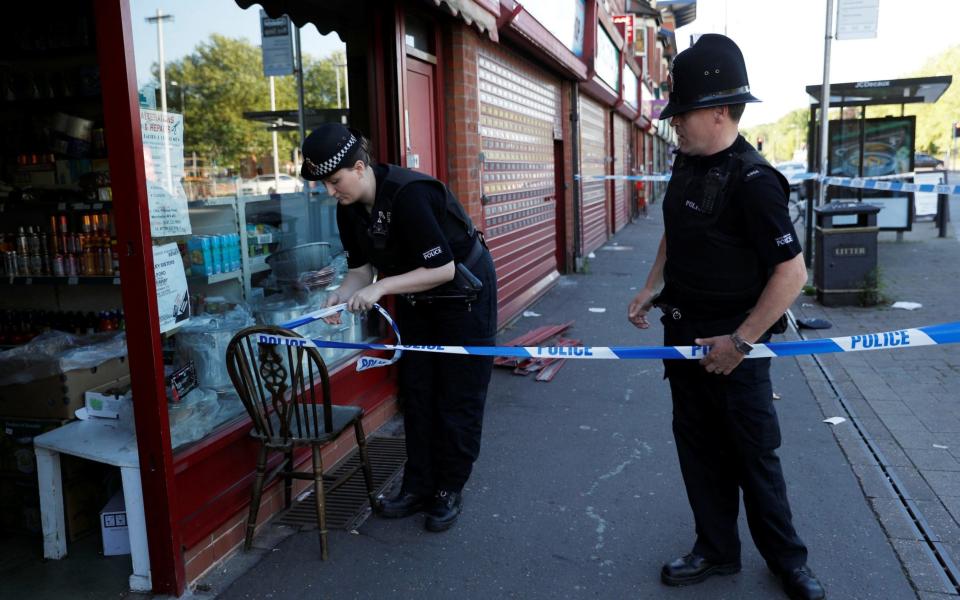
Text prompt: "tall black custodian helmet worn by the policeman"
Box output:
[[660, 33, 760, 119]]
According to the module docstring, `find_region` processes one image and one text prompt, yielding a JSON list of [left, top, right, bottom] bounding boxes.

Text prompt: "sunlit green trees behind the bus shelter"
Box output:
[[743, 45, 960, 163]]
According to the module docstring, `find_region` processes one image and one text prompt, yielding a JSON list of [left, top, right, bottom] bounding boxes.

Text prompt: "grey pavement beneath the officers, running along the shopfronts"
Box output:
[[192, 193, 960, 600]]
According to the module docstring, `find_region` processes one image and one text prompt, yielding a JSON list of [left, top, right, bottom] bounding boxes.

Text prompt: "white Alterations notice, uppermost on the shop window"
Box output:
[[140, 108, 191, 237]]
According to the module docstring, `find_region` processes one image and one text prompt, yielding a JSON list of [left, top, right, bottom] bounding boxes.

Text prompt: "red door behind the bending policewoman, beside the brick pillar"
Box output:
[[406, 55, 439, 177]]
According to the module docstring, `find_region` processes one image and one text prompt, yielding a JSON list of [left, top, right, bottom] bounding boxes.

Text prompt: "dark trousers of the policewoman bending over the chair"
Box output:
[[397, 251, 497, 495]]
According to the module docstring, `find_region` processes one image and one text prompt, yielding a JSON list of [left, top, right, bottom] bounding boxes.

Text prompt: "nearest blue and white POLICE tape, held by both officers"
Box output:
[[266, 304, 960, 371]]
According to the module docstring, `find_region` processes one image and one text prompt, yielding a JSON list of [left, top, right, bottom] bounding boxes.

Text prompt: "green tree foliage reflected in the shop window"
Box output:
[[155, 34, 345, 170]]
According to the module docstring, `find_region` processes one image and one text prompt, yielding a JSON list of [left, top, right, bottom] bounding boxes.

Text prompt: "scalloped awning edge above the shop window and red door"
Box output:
[[235, 0, 497, 41]]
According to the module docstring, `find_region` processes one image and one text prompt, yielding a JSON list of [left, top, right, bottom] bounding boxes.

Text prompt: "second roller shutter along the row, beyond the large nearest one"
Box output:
[[578, 95, 610, 255]]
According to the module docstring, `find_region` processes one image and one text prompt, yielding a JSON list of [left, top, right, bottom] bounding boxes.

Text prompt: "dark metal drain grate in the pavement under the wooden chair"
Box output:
[[275, 436, 407, 529]]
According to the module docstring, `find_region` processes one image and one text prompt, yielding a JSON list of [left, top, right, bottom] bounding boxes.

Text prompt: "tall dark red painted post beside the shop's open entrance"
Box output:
[[94, 0, 185, 596]]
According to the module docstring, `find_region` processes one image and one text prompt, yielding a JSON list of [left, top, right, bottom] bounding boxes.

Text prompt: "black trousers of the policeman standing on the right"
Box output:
[[661, 316, 807, 573]]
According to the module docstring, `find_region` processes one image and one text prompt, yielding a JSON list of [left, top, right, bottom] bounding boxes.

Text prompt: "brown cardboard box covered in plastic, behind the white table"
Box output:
[[0, 356, 130, 419]]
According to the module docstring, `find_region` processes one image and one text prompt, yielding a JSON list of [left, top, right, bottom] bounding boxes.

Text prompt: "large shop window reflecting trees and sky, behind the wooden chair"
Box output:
[[131, 0, 367, 448]]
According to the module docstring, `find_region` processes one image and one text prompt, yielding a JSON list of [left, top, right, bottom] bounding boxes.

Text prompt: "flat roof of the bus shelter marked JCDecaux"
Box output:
[[806, 75, 953, 107]]
